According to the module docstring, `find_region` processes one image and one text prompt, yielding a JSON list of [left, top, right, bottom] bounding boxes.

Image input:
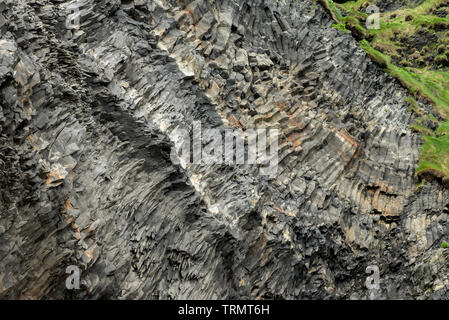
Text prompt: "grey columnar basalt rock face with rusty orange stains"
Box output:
[[0, 0, 449, 299]]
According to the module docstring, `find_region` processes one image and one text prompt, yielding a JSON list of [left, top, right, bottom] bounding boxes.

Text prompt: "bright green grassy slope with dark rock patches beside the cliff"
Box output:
[[319, 0, 449, 187]]
